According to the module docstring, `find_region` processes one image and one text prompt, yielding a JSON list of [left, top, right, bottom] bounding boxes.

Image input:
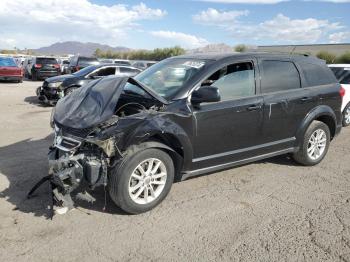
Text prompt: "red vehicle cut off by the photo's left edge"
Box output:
[[0, 57, 23, 83]]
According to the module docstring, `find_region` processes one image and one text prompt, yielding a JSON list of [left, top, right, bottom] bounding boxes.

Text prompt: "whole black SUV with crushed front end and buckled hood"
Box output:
[[29, 53, 345, 214]]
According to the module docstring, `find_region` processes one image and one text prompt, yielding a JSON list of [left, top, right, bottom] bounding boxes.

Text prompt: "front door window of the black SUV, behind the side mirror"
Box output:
[[202, 62, 255, 101]]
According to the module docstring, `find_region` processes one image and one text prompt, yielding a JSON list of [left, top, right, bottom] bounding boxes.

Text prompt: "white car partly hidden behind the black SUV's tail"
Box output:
[[329, 64, 350, 126]]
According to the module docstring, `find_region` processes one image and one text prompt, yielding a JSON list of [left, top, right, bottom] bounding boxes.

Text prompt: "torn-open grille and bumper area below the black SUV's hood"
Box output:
[[48, 126, 110, 212]]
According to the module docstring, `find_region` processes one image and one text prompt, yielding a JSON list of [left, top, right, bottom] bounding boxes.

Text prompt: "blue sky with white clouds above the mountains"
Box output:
[[0, 0, 350, 49]]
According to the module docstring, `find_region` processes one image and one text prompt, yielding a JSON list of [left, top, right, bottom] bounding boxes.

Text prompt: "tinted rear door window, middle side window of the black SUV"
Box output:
[[260, 60, 301, 93]]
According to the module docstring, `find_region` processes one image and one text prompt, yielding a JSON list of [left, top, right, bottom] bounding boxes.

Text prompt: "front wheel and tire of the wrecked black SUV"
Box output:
[[109, 148, 175, 214]]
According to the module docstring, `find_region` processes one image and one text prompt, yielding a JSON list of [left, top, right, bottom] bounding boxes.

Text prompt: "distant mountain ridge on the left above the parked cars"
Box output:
[[33, 41, 130, 56]]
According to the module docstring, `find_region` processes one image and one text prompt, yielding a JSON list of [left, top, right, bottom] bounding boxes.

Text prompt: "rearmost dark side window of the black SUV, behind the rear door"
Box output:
[[299, 63, 337, 87]]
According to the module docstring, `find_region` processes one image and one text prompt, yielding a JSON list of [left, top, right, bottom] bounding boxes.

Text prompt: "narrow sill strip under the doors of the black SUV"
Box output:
[[181, 147, 296, 180]]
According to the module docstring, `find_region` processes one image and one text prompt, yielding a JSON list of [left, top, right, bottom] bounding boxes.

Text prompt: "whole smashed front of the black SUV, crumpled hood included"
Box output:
[[28, 78, 164, 216]]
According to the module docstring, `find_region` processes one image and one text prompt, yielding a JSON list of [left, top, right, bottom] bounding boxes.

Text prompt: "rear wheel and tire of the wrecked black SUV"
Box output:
[[293, 121, 331, 166]]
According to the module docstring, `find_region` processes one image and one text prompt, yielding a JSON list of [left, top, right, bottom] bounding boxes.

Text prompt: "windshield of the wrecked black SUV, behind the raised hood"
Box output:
[[124, 58, 206, 100]]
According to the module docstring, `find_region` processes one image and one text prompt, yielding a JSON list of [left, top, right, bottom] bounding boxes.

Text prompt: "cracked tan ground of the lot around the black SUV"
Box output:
[[0, 82, 350, 262]]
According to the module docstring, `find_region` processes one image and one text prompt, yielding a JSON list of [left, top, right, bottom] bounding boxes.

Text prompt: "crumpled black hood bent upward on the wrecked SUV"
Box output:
[[54, 77, 128, 129]]
